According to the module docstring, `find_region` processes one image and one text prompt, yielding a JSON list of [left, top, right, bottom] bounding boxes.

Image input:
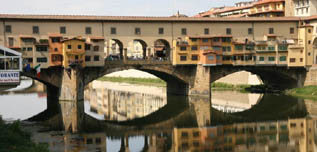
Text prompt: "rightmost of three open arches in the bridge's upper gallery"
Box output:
[[154, 39, 171, 60]]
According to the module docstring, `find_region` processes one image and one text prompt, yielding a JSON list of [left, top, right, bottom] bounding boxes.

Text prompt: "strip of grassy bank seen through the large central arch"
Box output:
[[98, 77, 166, 87]]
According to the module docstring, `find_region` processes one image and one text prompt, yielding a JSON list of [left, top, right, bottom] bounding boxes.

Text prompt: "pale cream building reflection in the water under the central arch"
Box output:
[[85, 81, 167, 121]]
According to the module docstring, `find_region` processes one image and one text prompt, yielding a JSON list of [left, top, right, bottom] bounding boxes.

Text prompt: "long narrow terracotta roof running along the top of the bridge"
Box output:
[[0, 14, 301, 22]]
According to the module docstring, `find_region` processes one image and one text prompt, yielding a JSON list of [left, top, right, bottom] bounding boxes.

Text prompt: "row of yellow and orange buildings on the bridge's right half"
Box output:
[[173, 24, 315, 67]]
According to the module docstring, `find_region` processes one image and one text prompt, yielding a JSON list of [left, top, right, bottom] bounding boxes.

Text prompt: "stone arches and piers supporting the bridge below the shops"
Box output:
[[22, 60, 317, 100]]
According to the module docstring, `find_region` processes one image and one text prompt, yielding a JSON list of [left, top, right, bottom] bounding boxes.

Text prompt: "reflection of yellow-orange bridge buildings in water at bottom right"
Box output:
[[173, 117, 317, 152]]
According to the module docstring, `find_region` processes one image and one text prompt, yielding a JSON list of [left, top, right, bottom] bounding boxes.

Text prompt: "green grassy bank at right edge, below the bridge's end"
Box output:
[[285, 86, 317, 100]]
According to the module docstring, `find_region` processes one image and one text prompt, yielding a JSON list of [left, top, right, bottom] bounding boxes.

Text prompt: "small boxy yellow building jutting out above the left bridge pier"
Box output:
[[62, 38, 85, 68]]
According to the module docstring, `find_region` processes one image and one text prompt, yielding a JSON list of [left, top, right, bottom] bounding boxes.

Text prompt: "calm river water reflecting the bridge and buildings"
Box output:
[[0, 81, 317, 152]]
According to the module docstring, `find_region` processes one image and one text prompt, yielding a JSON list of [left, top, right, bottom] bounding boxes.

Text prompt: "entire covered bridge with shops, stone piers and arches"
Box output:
[[0, 14, 317, 132]]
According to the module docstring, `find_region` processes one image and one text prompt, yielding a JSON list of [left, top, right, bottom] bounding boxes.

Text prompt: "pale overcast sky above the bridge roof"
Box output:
[[0, 0, 246, 16]]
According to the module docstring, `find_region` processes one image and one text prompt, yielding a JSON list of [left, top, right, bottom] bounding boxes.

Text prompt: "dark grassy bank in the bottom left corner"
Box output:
[[0, 117, 48, 152]]
